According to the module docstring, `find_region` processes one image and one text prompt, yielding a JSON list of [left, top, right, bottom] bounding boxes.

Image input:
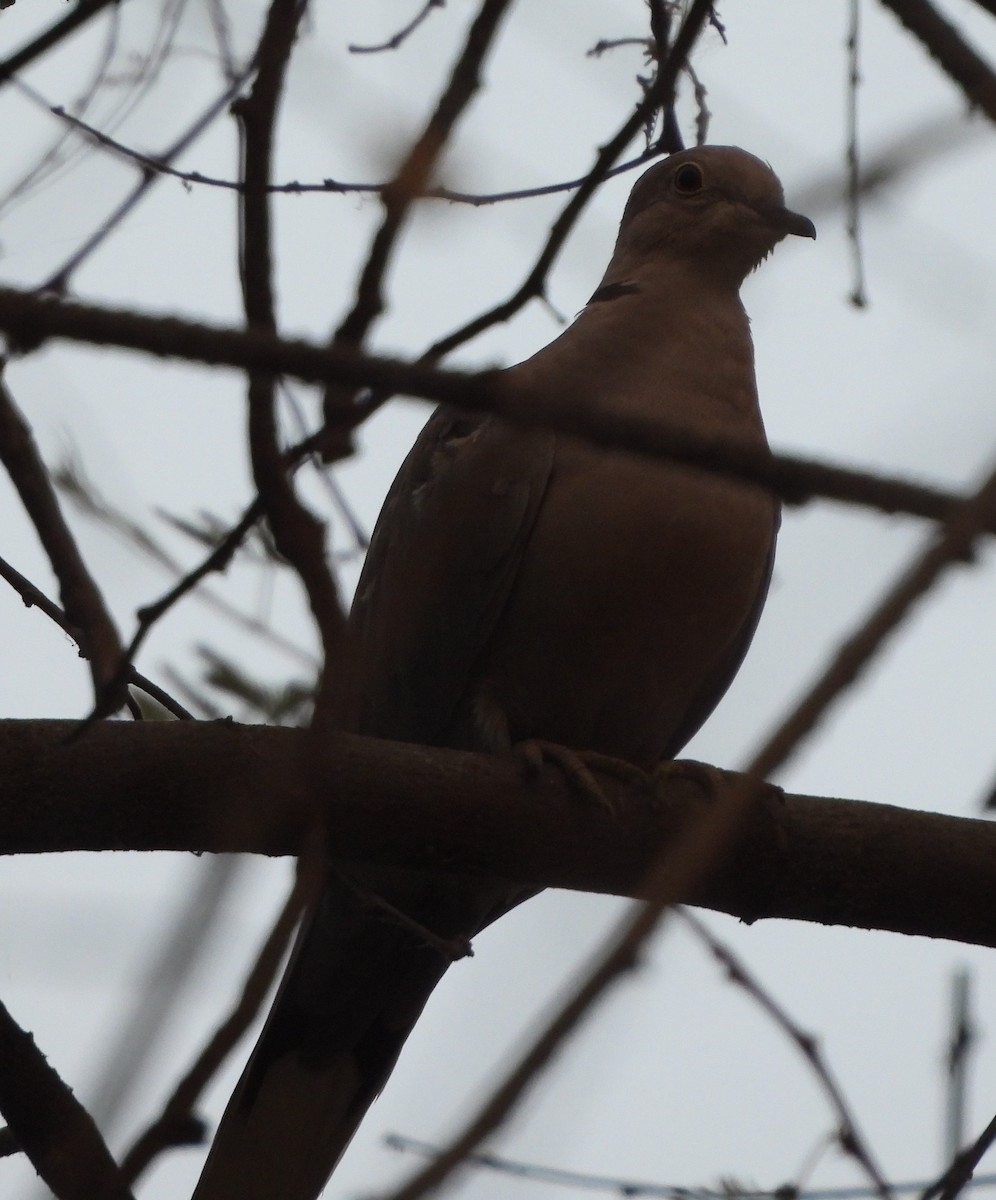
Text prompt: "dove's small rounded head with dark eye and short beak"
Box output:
[[616, 146, 816, 287]]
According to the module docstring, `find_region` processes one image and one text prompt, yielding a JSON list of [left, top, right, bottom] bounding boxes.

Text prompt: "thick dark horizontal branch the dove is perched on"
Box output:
[[0, 721, 996, 946]]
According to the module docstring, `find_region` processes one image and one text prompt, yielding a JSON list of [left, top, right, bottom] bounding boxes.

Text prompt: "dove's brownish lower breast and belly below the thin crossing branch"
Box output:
[[478, 440, 776, 767]]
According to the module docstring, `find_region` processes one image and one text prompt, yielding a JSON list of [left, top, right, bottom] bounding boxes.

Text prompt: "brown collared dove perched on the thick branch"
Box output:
[[194, 146, 815, 1200]]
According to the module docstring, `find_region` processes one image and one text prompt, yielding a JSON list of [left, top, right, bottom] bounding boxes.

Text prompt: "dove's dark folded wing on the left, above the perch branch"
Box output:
[[344, 408, 556, 745]]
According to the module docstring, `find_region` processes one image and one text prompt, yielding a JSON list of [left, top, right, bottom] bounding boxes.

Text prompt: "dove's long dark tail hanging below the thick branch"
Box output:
[[193, 869, 509, 1200]]
